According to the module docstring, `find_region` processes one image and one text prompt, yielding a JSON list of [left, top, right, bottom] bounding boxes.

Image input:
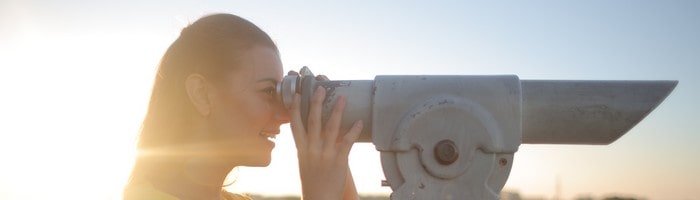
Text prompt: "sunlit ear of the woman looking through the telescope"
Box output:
[[185, 74, 211, 117]]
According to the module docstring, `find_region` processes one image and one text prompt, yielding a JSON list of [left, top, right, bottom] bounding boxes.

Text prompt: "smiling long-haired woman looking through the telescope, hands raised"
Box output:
[[124, 14, 362, 200]]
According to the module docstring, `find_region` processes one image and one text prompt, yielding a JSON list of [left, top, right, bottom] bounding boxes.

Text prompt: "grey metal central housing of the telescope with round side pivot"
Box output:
[[372, 76, 521, 200]]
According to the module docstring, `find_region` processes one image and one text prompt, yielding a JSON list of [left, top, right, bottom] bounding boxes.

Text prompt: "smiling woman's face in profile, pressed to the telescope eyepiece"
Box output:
[[208, 46, 289, 166]]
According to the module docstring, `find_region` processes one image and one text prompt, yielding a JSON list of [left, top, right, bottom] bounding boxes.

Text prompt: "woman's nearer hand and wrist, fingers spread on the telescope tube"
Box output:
[[290, 87, 362, 200]]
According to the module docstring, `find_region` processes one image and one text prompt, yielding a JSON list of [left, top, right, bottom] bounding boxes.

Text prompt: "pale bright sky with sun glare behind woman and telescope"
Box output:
[[0, 0, 700, 200]]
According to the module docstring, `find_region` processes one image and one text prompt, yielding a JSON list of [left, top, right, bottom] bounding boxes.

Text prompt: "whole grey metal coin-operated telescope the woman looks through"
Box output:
[[277, 67, 678, 200]]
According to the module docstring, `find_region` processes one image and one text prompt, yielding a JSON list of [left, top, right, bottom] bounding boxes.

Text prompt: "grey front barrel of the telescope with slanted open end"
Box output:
[[521, 80, 678, 144]]
